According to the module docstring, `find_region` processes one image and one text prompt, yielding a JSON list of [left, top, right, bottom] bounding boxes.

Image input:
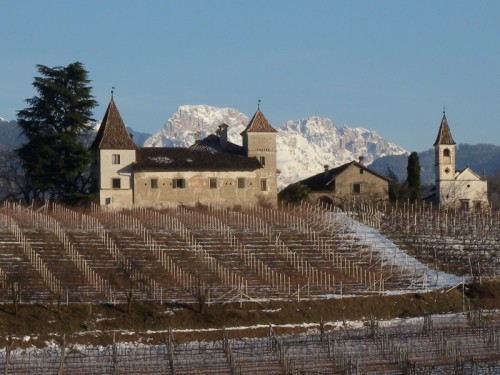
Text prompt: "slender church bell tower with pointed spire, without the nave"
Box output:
[[434, 112, 456, 205]]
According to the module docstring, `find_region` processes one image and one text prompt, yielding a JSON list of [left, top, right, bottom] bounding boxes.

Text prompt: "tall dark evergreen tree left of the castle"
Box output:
[[17, 62, 97, 203]]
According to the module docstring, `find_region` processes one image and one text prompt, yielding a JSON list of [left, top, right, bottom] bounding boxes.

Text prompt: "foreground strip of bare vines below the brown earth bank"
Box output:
[[0, 311, 500, 375]]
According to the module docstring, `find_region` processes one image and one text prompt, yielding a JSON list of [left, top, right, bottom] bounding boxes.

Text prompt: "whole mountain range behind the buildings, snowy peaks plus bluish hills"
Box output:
[[0, 105, 500, 188]]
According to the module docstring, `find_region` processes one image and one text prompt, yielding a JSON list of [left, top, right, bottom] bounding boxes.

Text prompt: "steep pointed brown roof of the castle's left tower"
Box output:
[[90, 99, 137, 150]]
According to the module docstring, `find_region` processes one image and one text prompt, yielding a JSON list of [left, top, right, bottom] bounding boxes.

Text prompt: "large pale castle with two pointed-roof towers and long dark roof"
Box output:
[[91, 99, 277, 208]]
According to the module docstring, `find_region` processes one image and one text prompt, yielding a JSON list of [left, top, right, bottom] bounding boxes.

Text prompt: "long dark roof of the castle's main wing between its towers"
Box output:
[[134, 147, 262, 172]]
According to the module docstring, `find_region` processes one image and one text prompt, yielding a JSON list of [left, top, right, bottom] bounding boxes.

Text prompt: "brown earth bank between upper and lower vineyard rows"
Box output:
[[0, 281, 500, 345]]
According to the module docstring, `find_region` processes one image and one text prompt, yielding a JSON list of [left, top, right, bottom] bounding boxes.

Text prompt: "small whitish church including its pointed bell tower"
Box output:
[[433, 112, 489, 211]]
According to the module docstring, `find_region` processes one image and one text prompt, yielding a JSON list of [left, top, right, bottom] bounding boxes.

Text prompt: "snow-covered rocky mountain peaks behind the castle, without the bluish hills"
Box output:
[[144, 105, 406, 188]]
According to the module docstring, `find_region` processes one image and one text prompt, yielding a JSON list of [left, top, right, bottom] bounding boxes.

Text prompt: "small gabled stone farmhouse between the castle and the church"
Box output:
[[290, 158, 390, 205]]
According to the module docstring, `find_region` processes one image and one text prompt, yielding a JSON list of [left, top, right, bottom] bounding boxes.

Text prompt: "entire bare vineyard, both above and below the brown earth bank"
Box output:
[[0, 202, 500, 374]]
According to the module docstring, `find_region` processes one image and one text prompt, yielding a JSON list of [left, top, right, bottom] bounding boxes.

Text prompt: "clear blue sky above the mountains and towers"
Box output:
[[0, 0, 500, 151]]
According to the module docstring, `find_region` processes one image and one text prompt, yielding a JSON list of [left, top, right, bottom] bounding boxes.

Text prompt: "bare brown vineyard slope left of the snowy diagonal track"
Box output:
[[0, 203, 464, 303]]
